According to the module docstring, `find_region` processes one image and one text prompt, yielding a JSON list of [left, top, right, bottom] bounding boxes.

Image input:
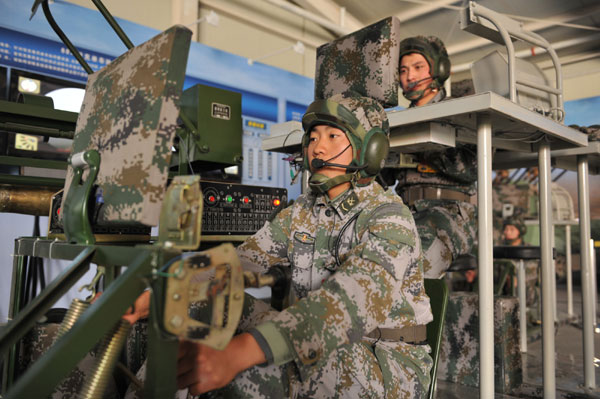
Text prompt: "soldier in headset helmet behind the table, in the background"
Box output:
[[395, 36, 477, 278]]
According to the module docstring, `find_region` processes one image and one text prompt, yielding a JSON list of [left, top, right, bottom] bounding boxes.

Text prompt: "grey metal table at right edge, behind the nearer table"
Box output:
[[494, 141, 600, 389]]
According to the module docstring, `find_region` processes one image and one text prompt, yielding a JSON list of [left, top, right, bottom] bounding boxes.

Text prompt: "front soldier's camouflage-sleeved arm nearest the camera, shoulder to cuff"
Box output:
[[246, 203, 422, 378]]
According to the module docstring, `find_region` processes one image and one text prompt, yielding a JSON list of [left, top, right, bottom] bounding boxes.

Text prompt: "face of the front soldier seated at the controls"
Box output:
[[307, 125, 352, 177]]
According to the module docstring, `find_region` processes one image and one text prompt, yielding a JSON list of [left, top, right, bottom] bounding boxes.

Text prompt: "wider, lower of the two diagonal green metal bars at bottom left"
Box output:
[[5, 251, 153, 399]]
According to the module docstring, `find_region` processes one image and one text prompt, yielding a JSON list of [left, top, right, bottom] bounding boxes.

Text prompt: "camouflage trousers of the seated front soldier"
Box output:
[[126, 295, 430, 399]]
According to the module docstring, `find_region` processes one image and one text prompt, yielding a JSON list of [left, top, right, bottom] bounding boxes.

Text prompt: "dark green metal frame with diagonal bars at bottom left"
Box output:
[[0, 237, 180, 398]]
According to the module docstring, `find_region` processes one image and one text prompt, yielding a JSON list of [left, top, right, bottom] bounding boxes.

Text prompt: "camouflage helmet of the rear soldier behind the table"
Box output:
[[399, 36, 450, 89]]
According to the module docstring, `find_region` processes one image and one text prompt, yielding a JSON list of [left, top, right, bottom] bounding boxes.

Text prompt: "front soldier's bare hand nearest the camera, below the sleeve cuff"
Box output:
[[177, 333, 266, 395]]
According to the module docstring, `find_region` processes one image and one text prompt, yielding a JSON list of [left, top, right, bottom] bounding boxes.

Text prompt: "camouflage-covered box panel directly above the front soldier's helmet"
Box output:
[[315, 17, 400, 107]]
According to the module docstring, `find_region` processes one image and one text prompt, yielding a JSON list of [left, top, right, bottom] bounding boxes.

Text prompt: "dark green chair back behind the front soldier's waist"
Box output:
[[425, 278, 448, 398]]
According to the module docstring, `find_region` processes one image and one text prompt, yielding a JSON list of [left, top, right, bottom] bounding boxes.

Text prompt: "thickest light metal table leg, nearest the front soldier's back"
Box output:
[[477, 114, 494, 399]]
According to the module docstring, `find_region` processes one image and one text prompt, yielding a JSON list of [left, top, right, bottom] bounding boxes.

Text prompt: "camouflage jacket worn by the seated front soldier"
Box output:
[[238, 183, 433, 391]]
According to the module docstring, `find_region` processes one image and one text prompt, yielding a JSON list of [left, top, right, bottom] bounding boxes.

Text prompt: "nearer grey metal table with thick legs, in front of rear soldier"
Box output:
[[263, 92, 593, 398]]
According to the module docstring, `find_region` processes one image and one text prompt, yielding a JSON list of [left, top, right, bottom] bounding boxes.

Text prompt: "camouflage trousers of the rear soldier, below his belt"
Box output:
[[413, 199, 477, 278]]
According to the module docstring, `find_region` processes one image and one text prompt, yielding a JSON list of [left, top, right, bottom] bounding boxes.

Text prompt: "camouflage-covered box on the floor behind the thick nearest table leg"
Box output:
[[438, 292, 523, 394]]
